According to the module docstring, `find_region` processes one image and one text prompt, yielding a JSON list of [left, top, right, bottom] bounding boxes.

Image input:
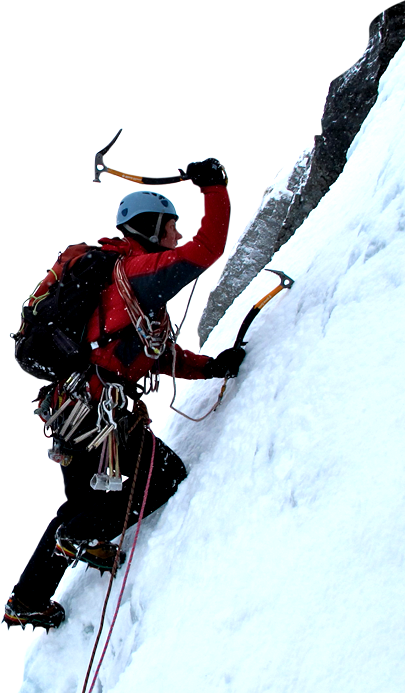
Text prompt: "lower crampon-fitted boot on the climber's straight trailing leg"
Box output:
[[1, 594, 65, 632]]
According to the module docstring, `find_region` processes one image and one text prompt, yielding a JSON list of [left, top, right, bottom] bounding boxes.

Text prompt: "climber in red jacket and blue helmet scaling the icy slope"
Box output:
[[3, 158, 245, 629]]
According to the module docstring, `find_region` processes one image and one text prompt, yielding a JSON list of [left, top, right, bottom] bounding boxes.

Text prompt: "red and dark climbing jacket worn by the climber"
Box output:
[[87, 185, 230, 390]]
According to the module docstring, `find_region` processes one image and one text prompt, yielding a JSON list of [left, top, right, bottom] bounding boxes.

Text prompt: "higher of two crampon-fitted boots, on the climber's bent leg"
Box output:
[[54, 525, 126, 575]]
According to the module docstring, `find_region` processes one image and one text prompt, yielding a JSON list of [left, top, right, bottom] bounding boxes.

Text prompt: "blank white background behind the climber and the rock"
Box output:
[[0, 3, 385, 693]]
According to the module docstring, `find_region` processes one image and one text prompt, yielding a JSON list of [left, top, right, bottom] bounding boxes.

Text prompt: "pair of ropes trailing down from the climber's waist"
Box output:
[[82, 401, 156, 693]]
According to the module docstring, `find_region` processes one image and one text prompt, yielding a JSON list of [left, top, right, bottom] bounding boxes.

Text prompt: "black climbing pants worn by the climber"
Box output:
[[14, 418, 187, 610]]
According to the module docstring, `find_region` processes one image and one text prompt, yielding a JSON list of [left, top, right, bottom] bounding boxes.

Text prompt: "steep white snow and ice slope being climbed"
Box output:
[[20, 46, 405, 693]]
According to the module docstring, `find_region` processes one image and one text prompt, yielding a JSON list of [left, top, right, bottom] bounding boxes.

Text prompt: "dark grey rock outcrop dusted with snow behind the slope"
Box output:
[[198, 0, 405, 344]]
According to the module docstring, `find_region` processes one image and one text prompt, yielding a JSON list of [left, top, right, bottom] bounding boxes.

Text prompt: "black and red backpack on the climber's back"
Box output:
[[10, 243, 119, 382]]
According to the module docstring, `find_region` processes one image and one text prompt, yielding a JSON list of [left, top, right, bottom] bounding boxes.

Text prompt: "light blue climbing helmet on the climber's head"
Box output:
[[115, 190, 180, 243]]
